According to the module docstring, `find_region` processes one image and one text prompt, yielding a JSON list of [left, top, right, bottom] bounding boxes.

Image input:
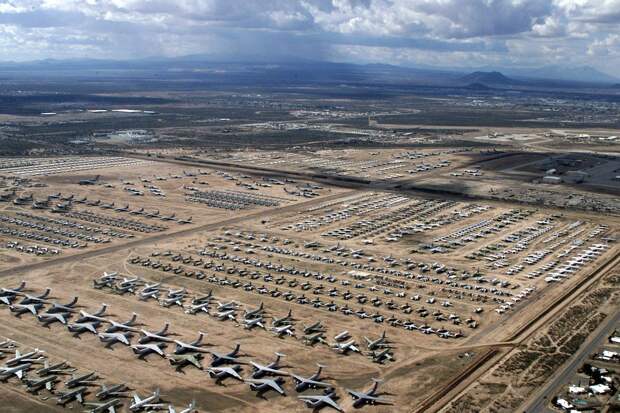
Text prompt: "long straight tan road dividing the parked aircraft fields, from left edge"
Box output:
[[0, 192, 351, 277]]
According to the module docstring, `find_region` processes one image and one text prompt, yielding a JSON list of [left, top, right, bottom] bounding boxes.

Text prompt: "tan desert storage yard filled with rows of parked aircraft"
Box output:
[[0, 149, 619, 412]]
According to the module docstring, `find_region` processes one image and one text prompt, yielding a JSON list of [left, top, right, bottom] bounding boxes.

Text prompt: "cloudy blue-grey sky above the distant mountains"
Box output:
[[0, 0, 620, 75]]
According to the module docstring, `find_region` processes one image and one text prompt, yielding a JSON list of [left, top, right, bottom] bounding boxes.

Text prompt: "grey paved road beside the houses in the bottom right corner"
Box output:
[[523, 311, 620, 413]]
